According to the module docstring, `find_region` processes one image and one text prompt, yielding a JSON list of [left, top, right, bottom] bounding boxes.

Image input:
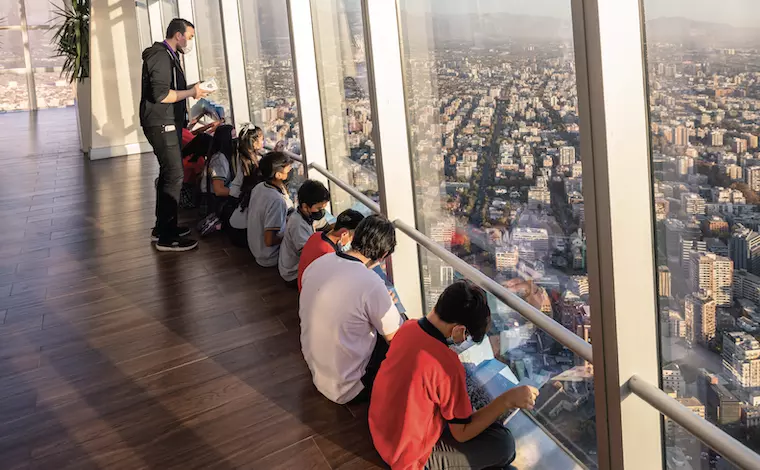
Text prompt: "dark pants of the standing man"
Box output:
[[143, 126, 184, 242]]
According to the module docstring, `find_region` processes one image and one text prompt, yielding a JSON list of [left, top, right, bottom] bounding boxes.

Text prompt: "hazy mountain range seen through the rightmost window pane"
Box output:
[[646, 18, 760, 48]]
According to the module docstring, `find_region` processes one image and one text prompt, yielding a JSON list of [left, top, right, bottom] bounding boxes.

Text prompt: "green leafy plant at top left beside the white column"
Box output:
[[51, 0, 90, 83]]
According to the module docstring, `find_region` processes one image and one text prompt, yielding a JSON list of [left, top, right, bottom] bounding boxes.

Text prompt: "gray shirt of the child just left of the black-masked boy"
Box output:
[[246, 183, 293, 268]]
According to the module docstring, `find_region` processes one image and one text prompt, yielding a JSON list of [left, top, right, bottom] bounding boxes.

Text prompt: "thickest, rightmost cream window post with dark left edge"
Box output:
[[572, 0, 663, 470]]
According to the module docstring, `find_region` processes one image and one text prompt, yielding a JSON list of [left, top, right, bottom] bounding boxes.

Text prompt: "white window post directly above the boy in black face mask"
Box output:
[[287, 0, 328, 189]]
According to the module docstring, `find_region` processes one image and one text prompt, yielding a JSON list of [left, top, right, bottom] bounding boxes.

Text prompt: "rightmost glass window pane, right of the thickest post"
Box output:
[[644, 0, 760, 465]]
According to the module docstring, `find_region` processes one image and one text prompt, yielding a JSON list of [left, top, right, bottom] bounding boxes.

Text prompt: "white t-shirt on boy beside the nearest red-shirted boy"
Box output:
[[298, 253, 403, 405]]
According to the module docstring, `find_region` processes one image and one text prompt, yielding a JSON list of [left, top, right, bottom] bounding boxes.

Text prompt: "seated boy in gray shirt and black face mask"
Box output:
[[278, 180, 330, 287]]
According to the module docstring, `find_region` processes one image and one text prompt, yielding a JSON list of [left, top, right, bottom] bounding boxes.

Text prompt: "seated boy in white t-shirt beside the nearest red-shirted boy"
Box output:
[[298, 215, 404, 405]]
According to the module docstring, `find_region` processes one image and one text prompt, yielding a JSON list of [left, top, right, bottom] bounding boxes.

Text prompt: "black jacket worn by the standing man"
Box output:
[[140, 42, 187, 127]]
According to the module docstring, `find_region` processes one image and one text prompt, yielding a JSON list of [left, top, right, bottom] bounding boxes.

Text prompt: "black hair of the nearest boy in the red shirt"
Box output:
[[435, 280, 491, 343]]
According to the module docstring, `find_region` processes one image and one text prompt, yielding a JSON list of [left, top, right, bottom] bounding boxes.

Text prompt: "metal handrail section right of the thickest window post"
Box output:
[[628, 374, 760, 469]]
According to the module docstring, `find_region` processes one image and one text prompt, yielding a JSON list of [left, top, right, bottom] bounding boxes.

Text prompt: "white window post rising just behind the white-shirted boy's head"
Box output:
[[362, 0, 426, 317]]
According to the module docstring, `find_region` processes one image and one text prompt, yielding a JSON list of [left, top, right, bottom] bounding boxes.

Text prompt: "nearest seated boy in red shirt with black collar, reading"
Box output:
[[369, 281, 538, 470]]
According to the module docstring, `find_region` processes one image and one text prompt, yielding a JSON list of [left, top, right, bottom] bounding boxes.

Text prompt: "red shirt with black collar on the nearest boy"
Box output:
[[369, 318, 472, 470]]
